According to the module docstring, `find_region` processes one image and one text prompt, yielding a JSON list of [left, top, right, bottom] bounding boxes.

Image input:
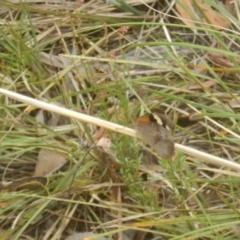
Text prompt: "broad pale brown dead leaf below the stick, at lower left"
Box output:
[[33, 149, 67, 177]]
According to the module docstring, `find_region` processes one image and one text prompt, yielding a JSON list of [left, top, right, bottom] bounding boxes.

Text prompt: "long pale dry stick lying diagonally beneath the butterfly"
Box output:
[[0, 88, 240, 170]]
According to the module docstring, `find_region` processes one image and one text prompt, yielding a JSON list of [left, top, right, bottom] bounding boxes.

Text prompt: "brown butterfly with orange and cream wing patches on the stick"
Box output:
[[135, 112, 174, 158]]
